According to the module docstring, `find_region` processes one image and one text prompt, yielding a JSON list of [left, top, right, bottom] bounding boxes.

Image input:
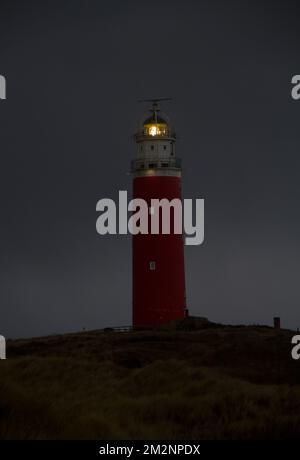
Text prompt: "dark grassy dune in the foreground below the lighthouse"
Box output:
[[0, 326, 300, 439]]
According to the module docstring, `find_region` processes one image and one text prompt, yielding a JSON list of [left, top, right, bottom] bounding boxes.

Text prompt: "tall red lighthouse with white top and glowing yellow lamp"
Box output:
[[131, 99, 187, 327]]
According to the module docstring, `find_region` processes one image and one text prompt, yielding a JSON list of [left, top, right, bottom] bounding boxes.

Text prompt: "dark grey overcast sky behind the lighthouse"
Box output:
[[0, 0, 300, 337]]
